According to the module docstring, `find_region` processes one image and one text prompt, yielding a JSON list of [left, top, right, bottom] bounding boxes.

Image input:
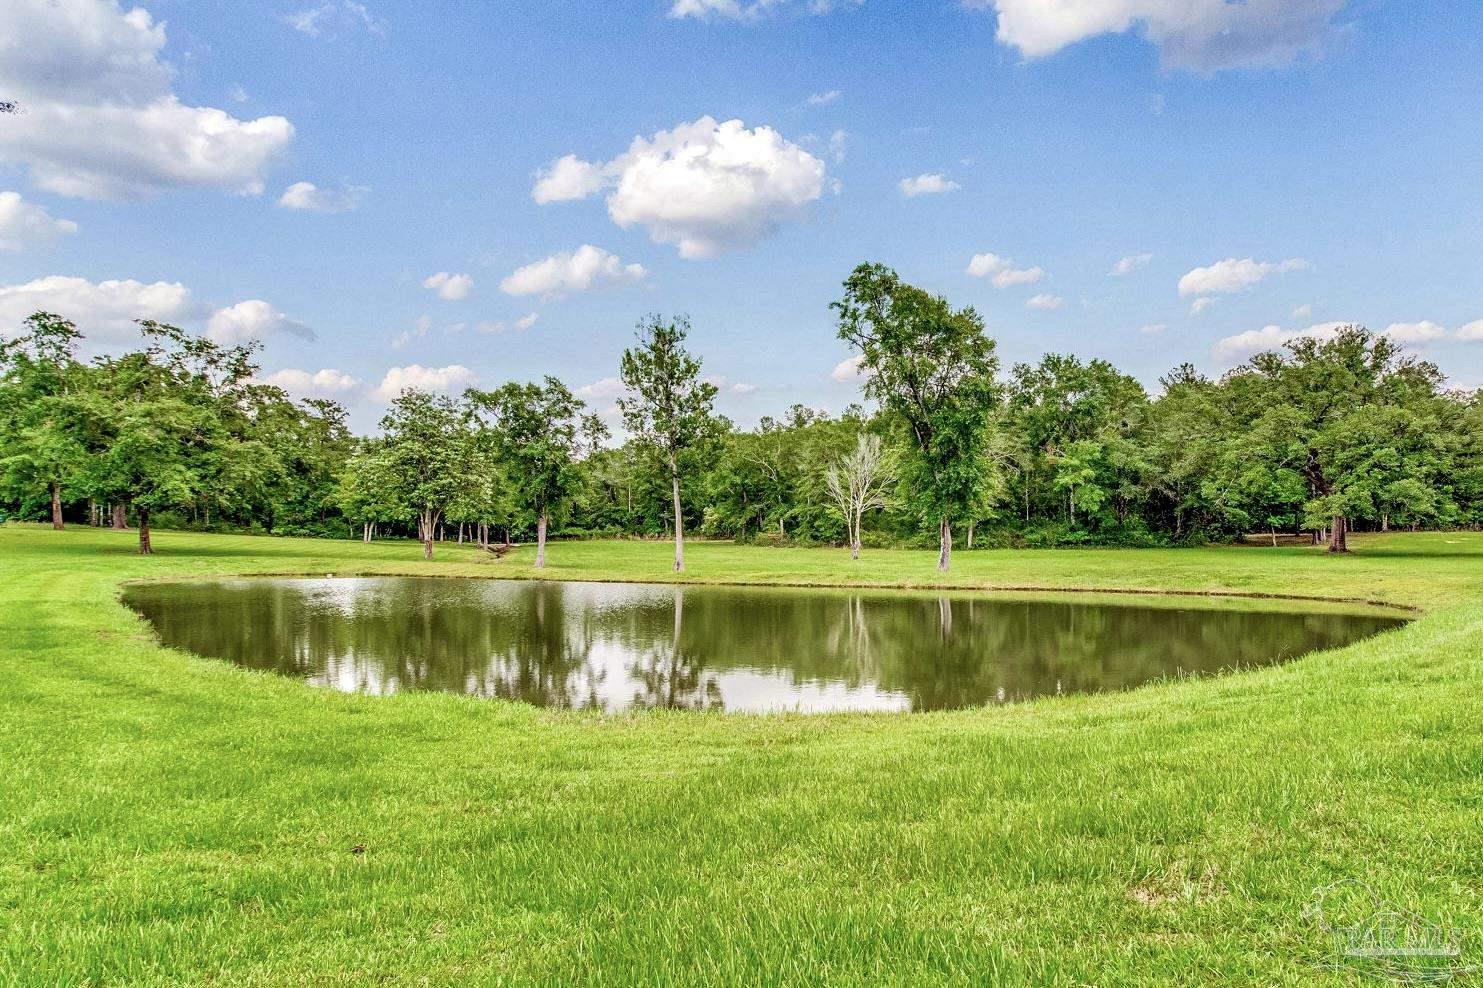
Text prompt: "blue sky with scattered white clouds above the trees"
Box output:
[[0, 0, 1483, 430]]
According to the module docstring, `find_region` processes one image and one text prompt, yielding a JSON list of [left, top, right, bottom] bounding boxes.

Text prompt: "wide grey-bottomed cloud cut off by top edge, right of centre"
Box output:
[[962, 0, 1345, 73]]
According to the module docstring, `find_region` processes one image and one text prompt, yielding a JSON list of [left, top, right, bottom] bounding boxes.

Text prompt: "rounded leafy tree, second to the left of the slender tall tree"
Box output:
[[380, 389, 472, 559]]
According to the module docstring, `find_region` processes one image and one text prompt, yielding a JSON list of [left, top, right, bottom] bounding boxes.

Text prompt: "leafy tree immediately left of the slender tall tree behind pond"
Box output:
[[466, 377, 607, 570]]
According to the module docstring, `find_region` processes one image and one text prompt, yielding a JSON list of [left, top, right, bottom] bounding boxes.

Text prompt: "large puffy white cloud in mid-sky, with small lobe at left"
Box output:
[[531, 117, 826, 258]]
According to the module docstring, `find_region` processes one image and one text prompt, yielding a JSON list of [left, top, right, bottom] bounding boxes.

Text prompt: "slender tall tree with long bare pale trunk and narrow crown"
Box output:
[[618, 316, 722, 573]]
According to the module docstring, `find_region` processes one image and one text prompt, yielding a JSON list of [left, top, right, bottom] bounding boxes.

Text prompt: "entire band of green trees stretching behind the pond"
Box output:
[[0, 264, 1483, 571]]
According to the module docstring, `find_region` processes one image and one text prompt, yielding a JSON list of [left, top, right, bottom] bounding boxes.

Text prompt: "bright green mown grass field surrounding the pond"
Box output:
[[0, 525, 1483, 985]]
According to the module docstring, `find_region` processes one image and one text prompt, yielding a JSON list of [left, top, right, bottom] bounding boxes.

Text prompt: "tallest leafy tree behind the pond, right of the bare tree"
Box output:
[[830, 264, 1000, 573]]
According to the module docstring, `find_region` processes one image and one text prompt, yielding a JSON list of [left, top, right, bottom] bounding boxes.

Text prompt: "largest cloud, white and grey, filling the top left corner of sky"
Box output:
[[0, 0, 294, 199]]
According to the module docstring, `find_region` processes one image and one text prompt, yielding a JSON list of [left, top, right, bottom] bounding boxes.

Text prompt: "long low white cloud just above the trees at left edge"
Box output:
[[0, 274, 208, 343]]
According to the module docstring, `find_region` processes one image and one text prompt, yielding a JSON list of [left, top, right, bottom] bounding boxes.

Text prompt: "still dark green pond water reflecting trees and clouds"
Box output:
[[125, 577, 1403, 711]]
